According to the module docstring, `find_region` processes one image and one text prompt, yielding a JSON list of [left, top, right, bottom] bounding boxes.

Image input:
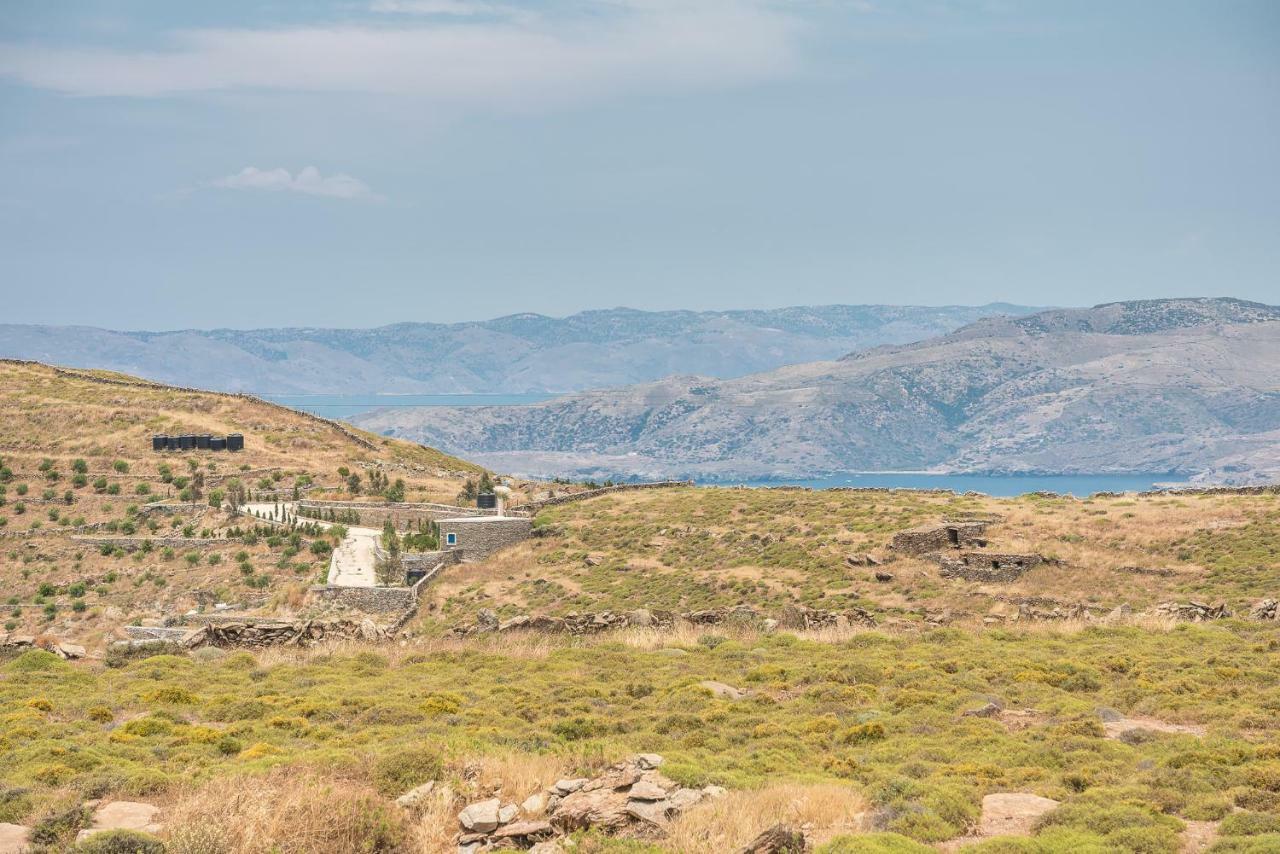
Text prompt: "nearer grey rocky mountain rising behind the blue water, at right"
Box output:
[[355, 300, 1280, 483]]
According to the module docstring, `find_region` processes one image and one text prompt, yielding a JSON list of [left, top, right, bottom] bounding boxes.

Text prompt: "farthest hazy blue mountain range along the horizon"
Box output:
[[0, 303, 1037, 394]]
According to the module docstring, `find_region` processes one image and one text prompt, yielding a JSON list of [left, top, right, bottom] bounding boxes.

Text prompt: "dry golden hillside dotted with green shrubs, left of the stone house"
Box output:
[[0, 361, 479, 645]]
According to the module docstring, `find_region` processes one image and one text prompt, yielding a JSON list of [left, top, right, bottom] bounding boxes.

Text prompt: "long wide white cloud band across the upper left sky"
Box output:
[[0, 0, 799, 110]]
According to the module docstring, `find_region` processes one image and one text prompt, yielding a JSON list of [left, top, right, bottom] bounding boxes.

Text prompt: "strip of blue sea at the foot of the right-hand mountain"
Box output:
[[727, 472, 1181, 498]]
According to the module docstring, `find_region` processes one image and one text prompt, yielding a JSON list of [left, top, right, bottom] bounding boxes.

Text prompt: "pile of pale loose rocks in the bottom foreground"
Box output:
[[457, 753, 727, 854]]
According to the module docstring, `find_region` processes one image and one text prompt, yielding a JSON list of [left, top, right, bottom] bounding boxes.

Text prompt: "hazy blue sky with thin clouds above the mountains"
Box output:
[[0, 0, 1280, 329]]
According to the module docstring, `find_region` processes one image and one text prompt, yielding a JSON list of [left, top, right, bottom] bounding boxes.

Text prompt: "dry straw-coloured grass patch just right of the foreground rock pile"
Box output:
[[664, 784, 868, 854]]
